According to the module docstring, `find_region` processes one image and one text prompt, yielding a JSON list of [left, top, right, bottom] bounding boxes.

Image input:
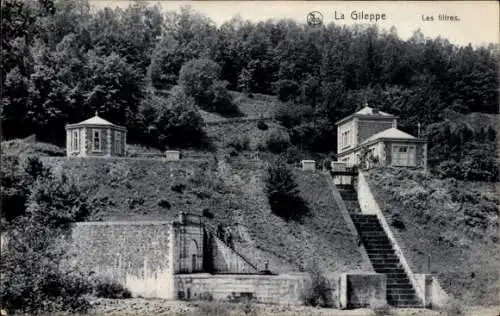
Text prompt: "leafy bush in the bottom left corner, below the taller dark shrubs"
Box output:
[[0, 222, 91, 313]]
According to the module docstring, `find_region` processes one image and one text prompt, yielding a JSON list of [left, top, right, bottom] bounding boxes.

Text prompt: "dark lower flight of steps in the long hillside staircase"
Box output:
[[352, 214, 422, 308]]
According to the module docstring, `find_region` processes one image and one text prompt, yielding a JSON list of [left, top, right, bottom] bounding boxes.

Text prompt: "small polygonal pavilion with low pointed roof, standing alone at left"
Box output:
[[66, 112, 127, 157]]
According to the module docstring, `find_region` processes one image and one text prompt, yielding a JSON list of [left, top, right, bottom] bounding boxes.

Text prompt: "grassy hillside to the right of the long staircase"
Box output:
[[368, 168, 500, 304]]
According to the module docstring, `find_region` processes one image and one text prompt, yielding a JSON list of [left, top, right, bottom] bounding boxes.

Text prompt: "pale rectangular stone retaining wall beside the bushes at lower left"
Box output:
[[72, 222, 174, 299]]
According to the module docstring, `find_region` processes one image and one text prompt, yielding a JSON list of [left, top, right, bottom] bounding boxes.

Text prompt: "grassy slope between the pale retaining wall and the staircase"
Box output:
[[38, 157, 369, 272]]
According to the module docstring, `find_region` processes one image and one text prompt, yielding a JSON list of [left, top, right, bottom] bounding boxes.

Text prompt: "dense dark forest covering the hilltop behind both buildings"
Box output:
[[1, 0, 499, 160]]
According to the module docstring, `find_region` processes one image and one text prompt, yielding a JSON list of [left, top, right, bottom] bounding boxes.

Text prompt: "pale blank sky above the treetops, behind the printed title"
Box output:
[[90, 0, 500, 46]]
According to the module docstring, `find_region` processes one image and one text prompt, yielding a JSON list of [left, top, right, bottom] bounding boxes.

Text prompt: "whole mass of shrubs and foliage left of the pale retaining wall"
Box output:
[[0, 157, 130, 313]]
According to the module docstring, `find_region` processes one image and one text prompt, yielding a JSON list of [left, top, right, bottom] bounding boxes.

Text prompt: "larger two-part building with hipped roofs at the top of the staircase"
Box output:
[[337, 106, 427, 169]]
